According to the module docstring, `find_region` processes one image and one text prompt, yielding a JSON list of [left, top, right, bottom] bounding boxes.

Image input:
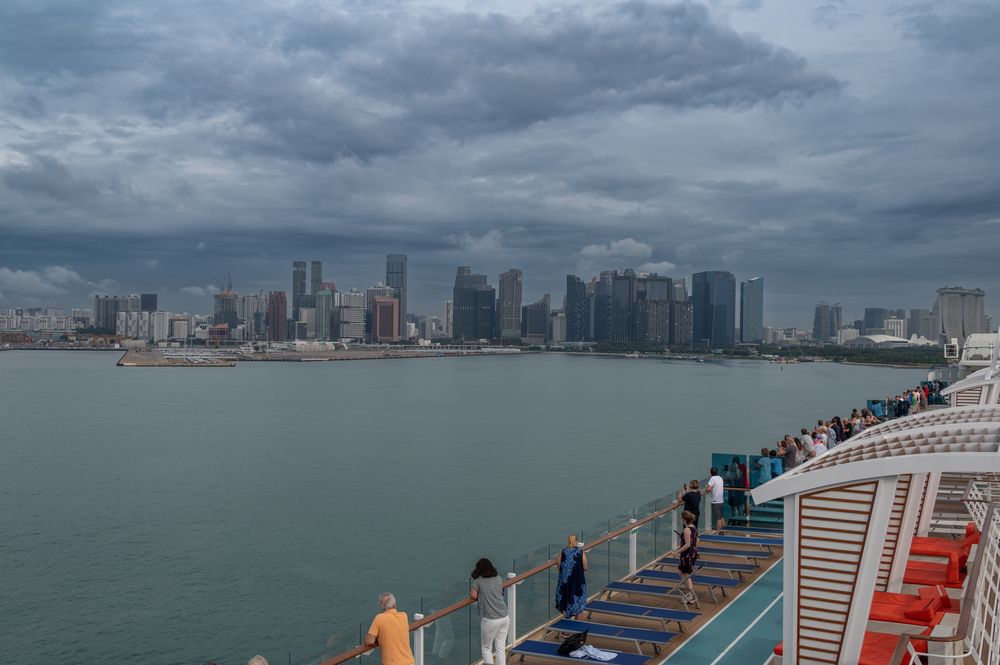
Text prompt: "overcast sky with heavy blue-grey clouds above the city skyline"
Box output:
[[0, 0, 1000, 326]]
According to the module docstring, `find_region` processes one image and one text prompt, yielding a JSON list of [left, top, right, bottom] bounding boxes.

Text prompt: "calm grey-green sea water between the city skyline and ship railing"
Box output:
[[0, 352, 925, 665]]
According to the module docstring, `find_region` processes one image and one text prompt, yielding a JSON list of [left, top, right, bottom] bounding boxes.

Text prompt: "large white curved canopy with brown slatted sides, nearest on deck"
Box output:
[[752, 405, 1000, 665]]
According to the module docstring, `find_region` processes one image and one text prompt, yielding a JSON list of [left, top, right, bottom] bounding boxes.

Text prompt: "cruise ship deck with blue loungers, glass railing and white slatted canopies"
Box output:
[[317, 358, 1000, 665]]
